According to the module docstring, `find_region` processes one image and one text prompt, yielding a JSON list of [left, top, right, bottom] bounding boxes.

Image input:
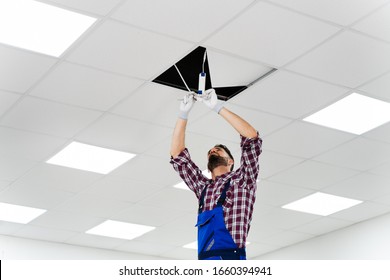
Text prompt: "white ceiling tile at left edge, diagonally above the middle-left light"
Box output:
[[1, 97, 101, 137]]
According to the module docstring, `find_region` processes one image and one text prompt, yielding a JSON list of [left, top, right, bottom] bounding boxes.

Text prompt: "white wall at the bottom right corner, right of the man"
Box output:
[[257, 214, 390, 260]]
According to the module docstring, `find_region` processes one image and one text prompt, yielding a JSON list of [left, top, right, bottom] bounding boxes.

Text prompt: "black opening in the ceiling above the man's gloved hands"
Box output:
[[153, 46, 276, 101]]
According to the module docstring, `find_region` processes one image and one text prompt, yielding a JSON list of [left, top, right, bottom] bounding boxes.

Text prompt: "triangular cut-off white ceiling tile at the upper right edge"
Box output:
[[353, 5, 390, 42]]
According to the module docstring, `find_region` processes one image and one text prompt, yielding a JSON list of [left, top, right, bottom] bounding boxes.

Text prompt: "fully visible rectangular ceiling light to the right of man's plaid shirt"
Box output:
[[282, 192, 362, 216]]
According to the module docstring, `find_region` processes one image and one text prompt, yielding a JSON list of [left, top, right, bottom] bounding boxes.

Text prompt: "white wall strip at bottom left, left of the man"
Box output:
[[0, 235, 166, 260]]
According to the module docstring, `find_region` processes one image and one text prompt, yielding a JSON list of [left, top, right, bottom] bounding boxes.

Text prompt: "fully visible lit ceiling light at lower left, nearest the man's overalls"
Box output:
[[86, 220, 155, 240]]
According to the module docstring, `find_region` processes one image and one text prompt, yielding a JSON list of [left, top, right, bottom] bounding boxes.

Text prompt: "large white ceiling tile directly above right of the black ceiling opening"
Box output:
[[206, 2, 339, 66]]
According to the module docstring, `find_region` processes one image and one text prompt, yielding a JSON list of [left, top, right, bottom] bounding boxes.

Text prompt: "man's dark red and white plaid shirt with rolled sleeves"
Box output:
[[170, 136, 262, 248]]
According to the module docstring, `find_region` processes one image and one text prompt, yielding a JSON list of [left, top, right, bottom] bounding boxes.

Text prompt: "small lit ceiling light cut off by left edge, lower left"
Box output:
[[0, 202, 47, 224]]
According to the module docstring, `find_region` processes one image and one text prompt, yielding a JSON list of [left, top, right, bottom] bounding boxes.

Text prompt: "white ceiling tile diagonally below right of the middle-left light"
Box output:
[[84, 175, 161, 203]]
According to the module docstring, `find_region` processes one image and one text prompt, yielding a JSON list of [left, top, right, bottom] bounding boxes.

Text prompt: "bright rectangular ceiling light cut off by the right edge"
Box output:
[[304, 93, 390, 135]]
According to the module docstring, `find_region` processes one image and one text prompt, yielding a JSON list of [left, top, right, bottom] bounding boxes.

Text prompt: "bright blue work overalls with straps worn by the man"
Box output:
[[196, 180, 246, 260]]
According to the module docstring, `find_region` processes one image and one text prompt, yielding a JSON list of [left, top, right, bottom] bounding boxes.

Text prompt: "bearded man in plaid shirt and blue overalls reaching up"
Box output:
[[171, 89, 262, 260]]
